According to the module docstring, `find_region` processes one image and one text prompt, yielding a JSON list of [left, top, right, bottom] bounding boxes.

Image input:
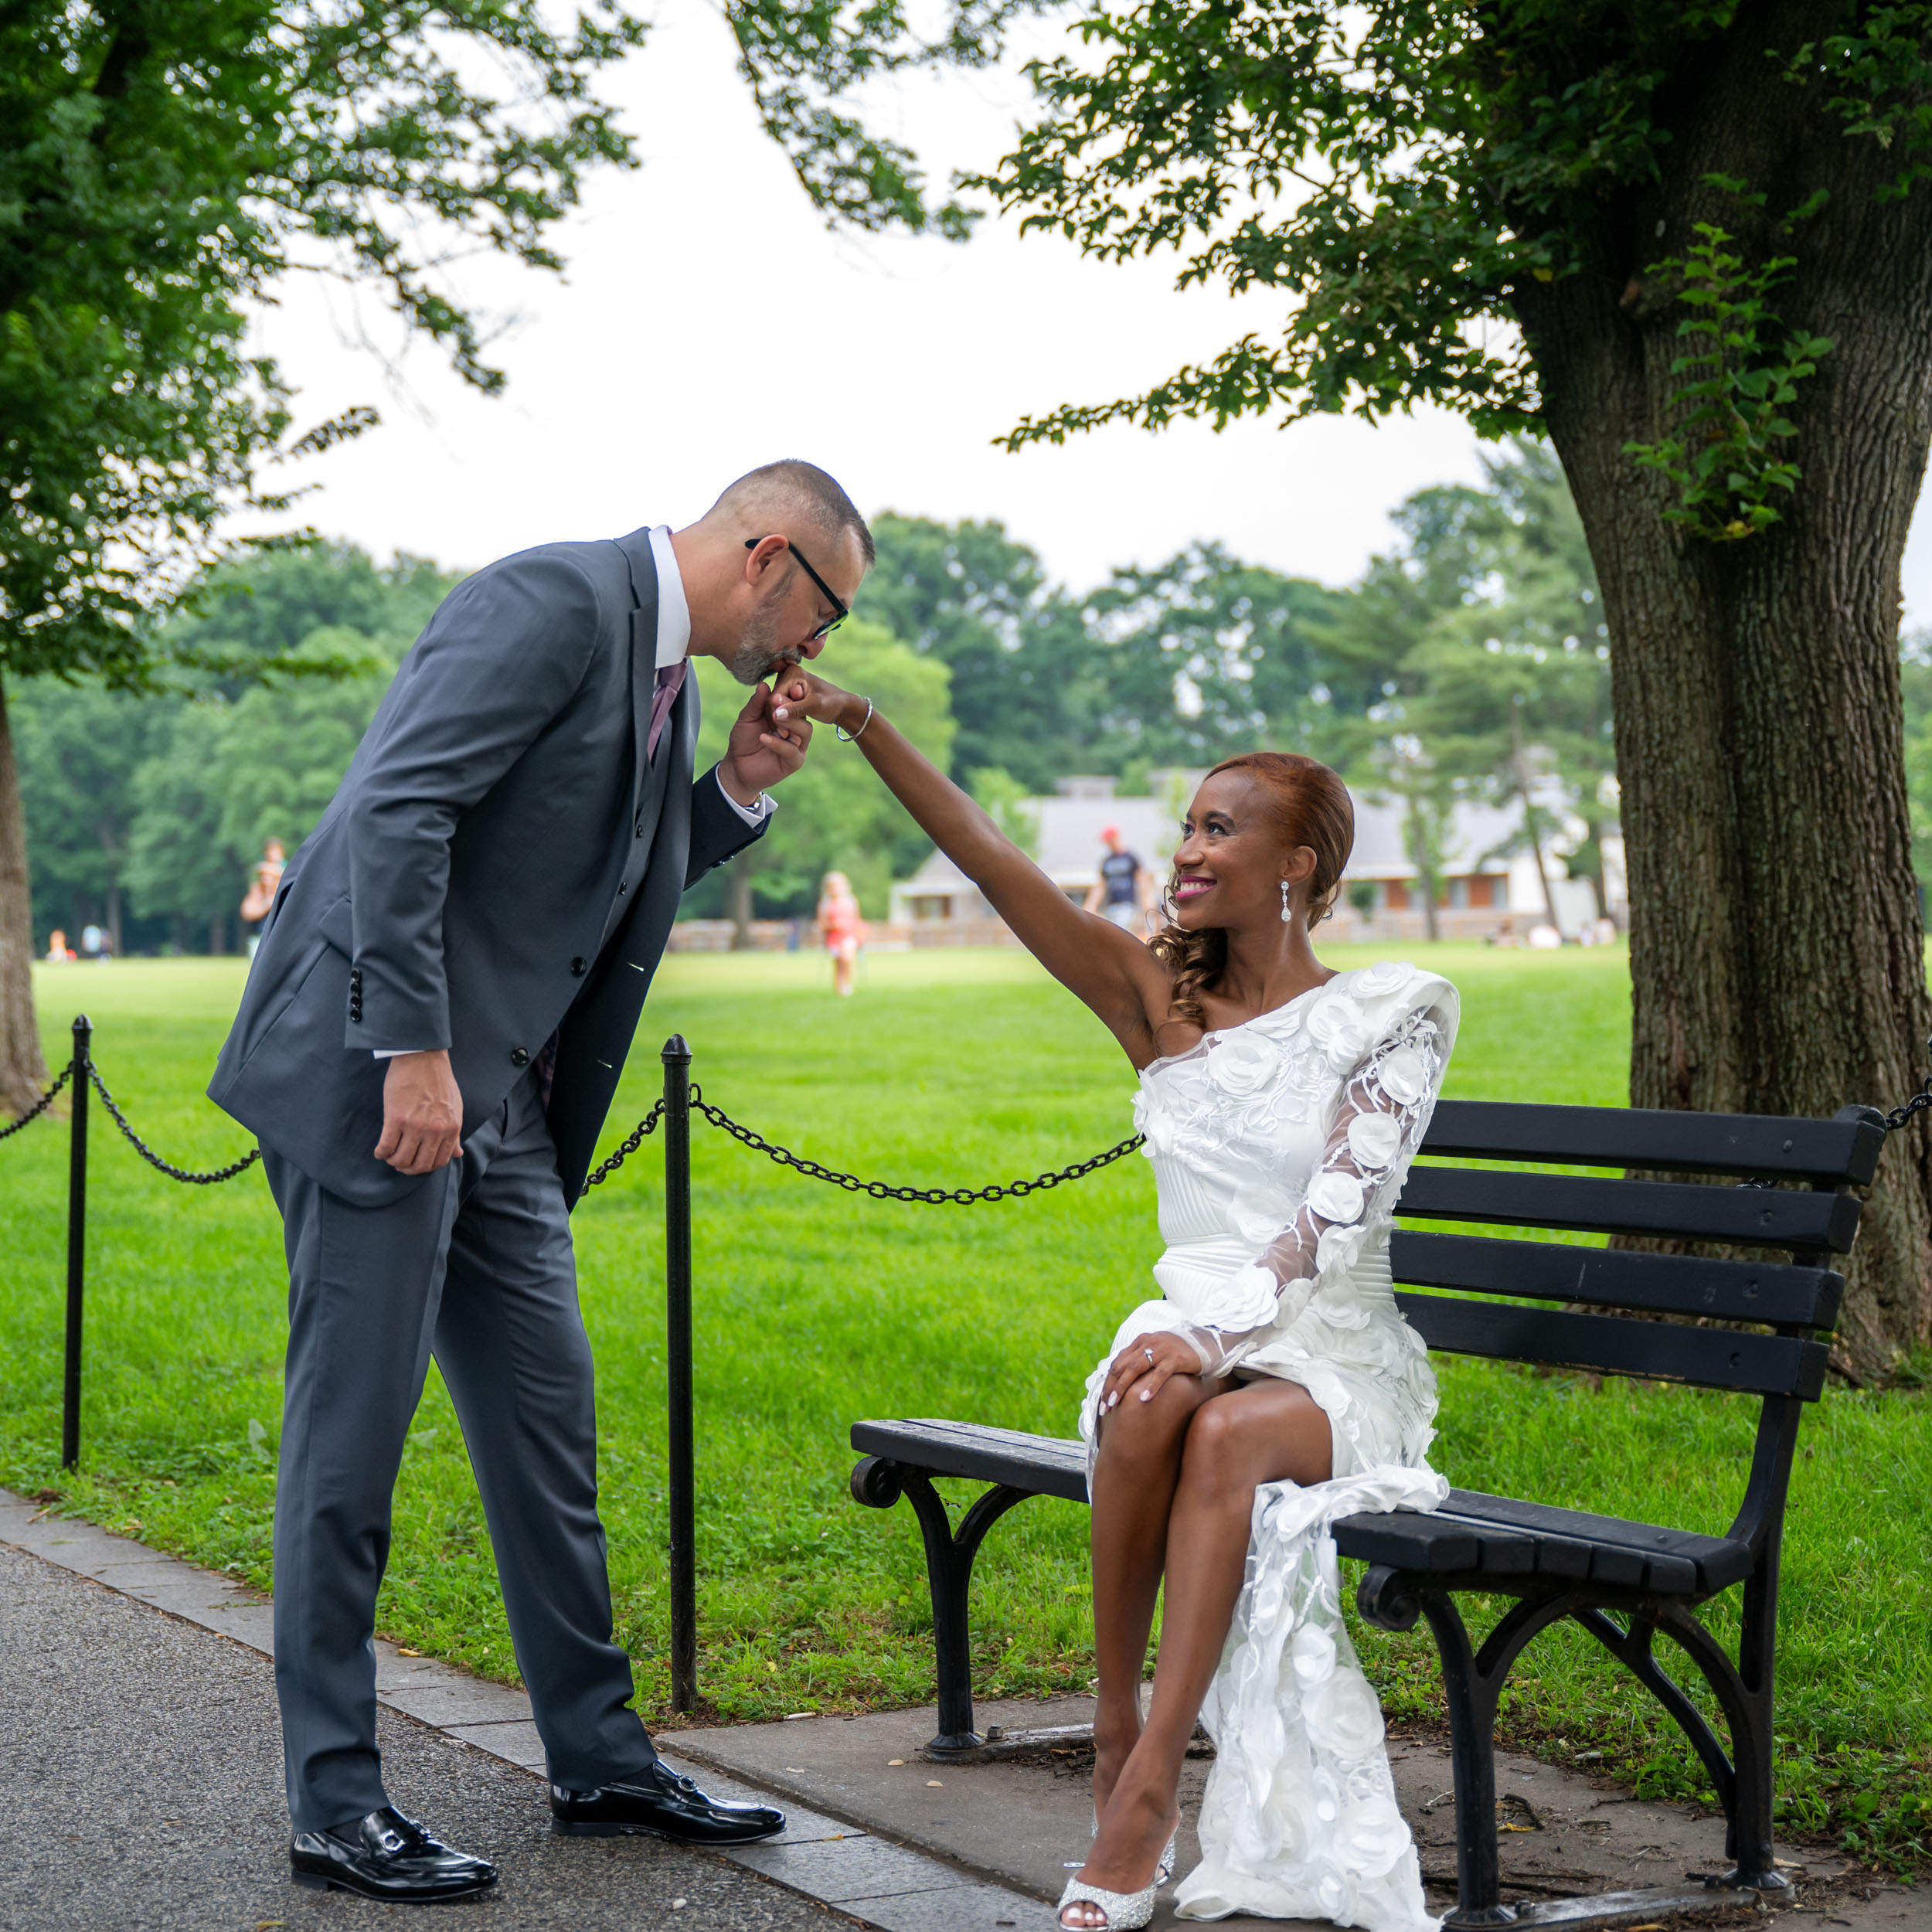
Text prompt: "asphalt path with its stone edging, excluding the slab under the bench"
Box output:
[[0, 1490, 1051, 1932]]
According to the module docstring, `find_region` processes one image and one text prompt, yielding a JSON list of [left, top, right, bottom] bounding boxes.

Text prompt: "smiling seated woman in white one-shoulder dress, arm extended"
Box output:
[[777, 672, 1457, 1932]]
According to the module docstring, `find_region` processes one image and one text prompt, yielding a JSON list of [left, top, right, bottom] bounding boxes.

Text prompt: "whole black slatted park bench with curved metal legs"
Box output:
[[852, 1101, 1886, 1928]]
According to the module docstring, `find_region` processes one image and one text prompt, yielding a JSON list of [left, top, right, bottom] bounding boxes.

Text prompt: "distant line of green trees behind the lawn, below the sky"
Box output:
[[41, 443, 1932, 951]]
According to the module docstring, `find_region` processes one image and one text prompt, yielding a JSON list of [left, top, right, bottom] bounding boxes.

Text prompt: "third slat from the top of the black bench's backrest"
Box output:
[[1389, 1229, 1845, 1329]]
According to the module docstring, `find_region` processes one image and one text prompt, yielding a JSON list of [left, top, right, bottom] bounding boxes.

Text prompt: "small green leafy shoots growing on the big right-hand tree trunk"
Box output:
[[1623, 217, 1832, 543]]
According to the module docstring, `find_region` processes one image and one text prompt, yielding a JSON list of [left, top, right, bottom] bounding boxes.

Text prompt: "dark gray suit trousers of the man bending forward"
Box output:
[[263, 1077, 655, 1832]]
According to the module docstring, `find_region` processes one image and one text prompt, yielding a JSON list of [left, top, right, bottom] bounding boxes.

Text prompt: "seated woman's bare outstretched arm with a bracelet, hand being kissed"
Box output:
[[775, 671, 1171, 1066]]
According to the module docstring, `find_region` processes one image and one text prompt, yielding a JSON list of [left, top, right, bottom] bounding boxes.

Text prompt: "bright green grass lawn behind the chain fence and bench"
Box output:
[[0, 947, 1932, 1866]]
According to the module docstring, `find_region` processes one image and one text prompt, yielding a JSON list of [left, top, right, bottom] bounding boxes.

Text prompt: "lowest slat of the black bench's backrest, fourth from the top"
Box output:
[[1395, 1294, 1828, 1403]]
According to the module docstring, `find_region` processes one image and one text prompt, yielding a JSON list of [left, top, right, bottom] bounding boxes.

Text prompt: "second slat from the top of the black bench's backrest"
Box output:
[[1395, 1167, 1859, 1254]]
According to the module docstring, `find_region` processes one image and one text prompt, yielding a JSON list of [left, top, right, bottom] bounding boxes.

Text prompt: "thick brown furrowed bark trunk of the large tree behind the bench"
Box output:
[[1519, 0, 1932, 1379]]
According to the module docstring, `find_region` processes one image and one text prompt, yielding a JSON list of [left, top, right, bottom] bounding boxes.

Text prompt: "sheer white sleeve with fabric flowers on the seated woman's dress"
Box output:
[[1182, 1007, 1447, 1376]]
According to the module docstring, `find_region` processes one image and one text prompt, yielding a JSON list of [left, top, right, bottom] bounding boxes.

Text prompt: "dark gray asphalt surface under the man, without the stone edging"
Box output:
[[0, 1549, 825, 1932]]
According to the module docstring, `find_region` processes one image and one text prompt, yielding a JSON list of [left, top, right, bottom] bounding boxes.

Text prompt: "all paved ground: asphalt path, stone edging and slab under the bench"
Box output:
[[0, 1492, 1932, 1932]]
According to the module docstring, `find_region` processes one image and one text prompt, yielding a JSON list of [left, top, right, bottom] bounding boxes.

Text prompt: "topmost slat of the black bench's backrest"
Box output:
[[1422, 1100, 1886, 1186]]
